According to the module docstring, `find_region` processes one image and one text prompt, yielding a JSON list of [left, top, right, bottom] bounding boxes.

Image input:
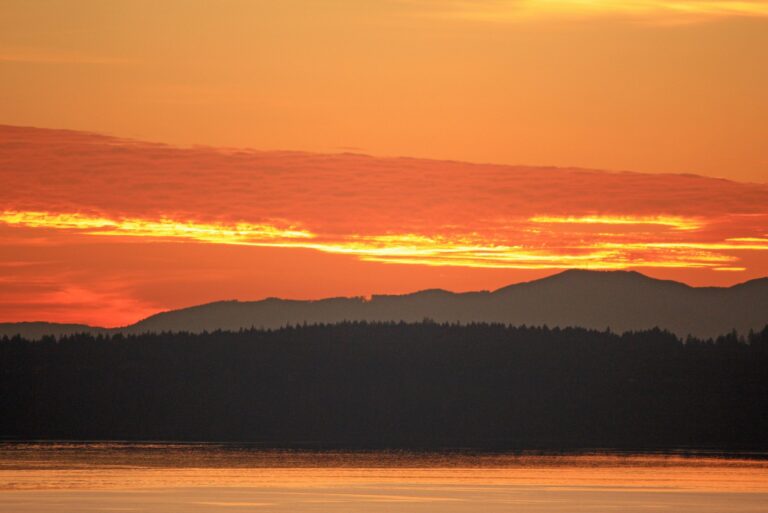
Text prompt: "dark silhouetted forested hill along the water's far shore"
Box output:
[[0, 323, 768, 450]]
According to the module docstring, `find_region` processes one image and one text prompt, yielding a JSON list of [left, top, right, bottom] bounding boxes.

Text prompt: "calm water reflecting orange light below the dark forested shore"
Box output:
[[0, 443, 768, 513]]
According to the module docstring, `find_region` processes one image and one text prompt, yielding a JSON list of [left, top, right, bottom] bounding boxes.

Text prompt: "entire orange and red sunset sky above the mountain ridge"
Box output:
[[0, 0, 768, 326]]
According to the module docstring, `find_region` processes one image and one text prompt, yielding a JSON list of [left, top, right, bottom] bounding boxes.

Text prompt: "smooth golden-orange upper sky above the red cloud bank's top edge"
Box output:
[[0, 0, 768, 182]]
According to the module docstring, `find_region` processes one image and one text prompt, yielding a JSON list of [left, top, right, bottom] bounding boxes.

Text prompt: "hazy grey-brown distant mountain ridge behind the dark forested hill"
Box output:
[[0, 270, 768, 338]]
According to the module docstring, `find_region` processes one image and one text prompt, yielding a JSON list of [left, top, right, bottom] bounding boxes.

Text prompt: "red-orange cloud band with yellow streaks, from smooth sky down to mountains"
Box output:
[[0, 126, 768, 324]]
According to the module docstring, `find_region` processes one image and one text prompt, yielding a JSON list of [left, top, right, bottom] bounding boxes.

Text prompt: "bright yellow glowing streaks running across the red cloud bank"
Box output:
[[0, 211, 768, 271]]
